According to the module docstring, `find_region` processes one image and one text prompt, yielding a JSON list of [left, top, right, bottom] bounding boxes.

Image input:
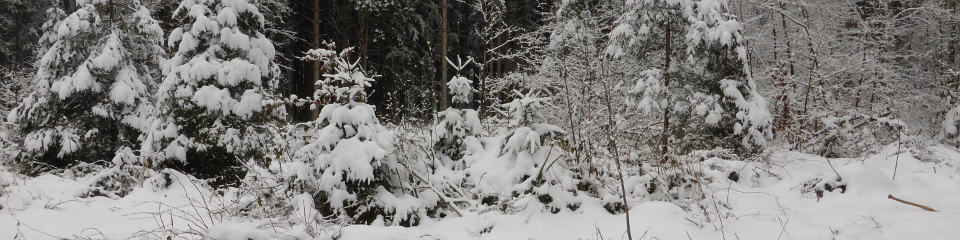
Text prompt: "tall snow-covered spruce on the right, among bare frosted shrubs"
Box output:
[[605, 0, 772, 156]]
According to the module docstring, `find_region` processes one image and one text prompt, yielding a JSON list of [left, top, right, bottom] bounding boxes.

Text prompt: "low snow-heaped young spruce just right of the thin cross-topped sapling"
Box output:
[[467, 92, 580, 213]]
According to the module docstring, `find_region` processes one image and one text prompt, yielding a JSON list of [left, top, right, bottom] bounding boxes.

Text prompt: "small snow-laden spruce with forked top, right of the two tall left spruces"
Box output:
[[284, 48, 421, 226]]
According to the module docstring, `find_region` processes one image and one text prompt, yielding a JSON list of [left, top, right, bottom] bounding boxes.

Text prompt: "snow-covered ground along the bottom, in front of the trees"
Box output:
[[0, 145, 960, 240]]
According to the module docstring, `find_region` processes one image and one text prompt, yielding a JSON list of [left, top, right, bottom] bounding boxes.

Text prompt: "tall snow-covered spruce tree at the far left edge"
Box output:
[[8, 0, 163, 172]]
